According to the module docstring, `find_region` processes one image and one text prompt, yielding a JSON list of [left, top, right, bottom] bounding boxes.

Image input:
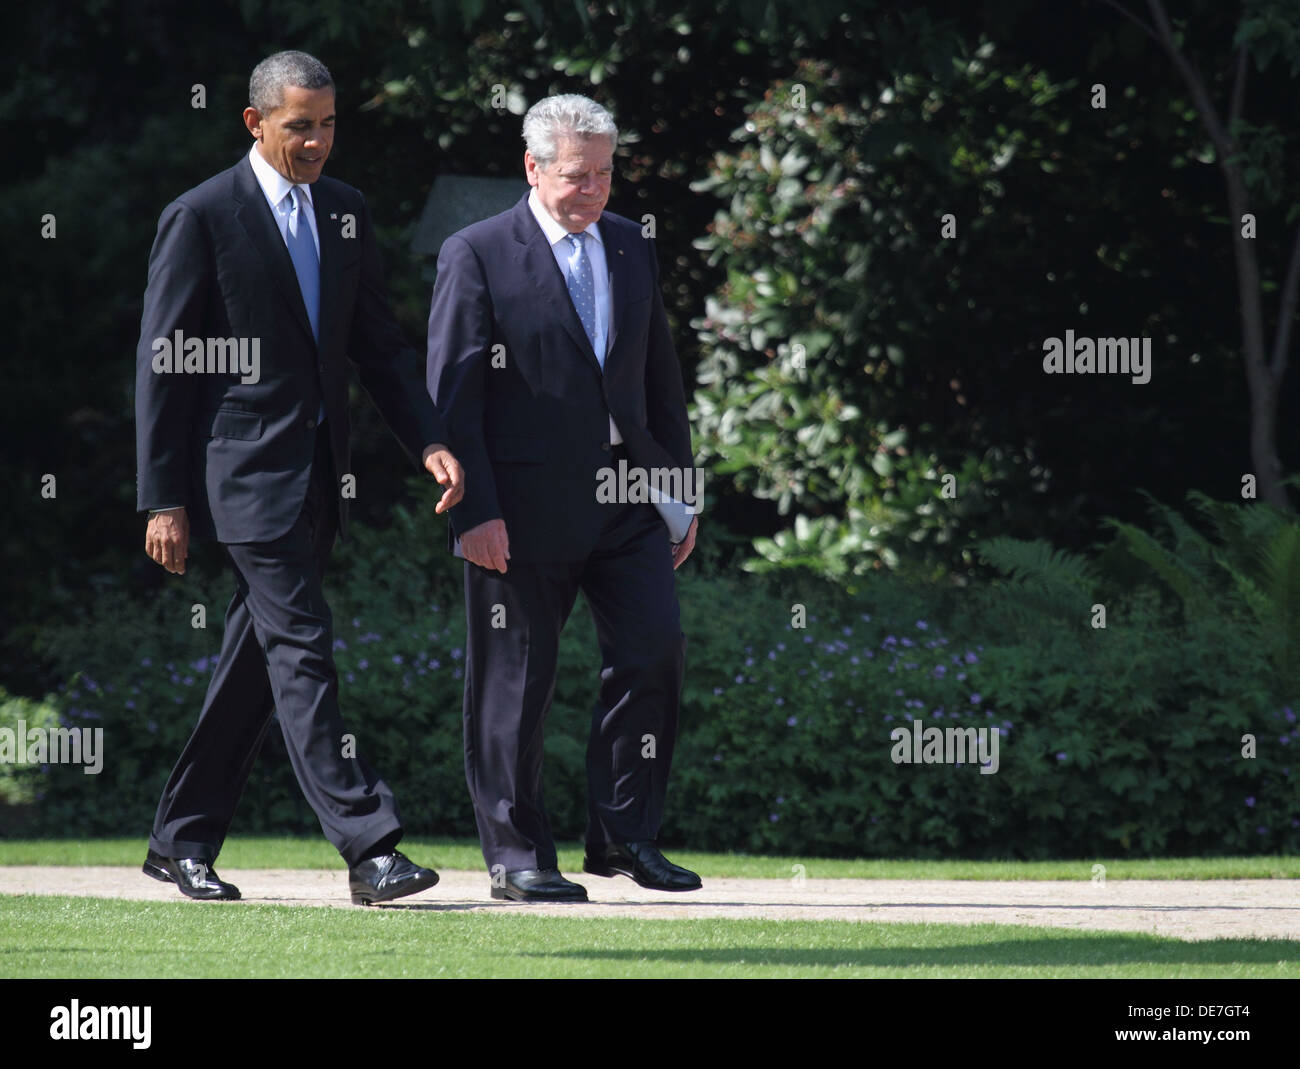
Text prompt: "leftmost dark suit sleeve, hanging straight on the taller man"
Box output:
[[135, 200, 212, 512]]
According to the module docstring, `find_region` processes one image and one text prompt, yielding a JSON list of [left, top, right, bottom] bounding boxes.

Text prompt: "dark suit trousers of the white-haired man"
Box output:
[[464, 488, 685, 871]]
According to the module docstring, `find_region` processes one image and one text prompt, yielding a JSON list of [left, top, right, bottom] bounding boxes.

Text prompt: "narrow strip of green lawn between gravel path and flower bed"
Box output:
[[0, 836, 1300, 880]]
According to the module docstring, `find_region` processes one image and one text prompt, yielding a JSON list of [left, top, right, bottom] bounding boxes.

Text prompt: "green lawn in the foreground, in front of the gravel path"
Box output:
[[0, 896, 1300, 978]]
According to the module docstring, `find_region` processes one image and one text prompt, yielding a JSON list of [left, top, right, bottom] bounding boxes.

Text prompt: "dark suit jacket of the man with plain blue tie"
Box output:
[[135, 157, 446, 542]]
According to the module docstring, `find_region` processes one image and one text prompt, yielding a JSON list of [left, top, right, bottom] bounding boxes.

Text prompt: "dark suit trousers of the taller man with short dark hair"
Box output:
[[150, 428, 402, 865]]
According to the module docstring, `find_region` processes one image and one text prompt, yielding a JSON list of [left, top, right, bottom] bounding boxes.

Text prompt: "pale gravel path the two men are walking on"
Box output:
[[0, 866, 1300, 939]]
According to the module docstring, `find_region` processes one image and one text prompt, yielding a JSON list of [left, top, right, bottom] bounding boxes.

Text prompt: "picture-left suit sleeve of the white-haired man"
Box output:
[[428, 234, 502, 537]]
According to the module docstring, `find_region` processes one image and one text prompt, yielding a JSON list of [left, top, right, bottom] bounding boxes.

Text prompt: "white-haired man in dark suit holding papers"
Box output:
[[428, 95, 701, 901]]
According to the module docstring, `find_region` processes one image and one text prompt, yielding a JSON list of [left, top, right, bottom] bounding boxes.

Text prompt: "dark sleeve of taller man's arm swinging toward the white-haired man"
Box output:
[[347, 194, 447, 464]]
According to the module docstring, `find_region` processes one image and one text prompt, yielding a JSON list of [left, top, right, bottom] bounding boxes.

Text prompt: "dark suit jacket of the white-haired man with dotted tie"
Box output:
[[428, 196, 692, 562]]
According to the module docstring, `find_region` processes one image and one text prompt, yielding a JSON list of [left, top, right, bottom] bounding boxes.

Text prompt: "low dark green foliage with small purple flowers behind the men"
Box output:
[[15, 484, 1300, 858]]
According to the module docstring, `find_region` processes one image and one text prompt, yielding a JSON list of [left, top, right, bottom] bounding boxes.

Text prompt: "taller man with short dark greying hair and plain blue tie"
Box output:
[[135, 52, 464, 905]]
